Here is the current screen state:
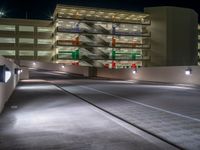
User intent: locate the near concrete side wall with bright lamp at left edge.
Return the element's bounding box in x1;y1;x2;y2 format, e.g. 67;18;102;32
0;56;19;113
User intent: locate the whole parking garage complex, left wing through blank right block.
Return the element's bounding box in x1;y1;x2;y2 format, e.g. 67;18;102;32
0;5;198;68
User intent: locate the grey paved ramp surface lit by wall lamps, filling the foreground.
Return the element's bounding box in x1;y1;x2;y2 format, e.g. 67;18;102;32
0;71;200;150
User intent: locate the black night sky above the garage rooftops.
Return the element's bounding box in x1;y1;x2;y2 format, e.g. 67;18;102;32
0;0;200;19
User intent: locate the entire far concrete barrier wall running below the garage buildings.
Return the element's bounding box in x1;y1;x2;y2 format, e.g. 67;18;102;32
20;61;200;85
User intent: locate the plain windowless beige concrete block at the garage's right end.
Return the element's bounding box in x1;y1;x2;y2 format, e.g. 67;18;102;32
145;7;198;66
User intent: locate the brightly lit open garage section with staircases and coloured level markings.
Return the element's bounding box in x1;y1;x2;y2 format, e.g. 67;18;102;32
54;5;151;68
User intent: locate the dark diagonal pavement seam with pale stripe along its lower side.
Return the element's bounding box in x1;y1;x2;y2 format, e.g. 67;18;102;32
52;83;182;150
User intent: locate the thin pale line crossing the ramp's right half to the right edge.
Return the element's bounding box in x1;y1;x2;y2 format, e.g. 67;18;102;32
79;86;200;122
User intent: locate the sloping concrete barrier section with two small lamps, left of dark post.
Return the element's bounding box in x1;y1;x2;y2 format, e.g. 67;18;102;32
20;60;89;77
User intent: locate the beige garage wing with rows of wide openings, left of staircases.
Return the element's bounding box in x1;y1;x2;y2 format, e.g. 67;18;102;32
0;18;53;62
